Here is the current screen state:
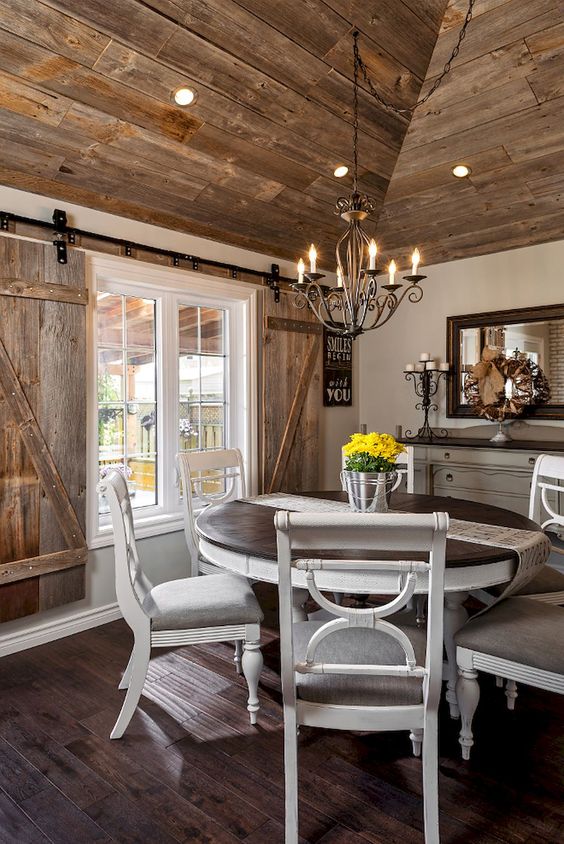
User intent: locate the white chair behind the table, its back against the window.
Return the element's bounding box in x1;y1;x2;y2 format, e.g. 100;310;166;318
176;448;247;576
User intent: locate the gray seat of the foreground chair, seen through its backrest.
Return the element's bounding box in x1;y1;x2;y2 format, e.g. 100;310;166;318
294;616;426;706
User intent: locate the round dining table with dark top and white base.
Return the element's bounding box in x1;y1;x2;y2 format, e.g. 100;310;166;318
196;492;540;718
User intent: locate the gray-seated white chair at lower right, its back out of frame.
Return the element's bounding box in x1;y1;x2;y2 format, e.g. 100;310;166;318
455;597;564;759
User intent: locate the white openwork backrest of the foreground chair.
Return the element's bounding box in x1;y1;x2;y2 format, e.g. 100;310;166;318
275;511;448;706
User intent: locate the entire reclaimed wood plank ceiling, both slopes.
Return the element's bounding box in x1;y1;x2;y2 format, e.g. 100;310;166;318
0;0;564;269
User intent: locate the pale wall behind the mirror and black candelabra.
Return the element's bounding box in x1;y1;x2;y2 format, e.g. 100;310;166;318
358;240;564;438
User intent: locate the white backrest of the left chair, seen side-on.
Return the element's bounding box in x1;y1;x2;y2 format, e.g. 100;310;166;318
97;469;153;626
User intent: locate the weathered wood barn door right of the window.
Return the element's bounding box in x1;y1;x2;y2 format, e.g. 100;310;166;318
262;291;323;492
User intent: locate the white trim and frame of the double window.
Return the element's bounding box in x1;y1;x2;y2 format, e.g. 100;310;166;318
86;254;259;548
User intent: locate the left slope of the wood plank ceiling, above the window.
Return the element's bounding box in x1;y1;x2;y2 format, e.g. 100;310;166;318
0;0;446;260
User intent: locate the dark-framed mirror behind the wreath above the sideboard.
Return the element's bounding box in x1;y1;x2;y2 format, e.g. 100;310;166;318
447;304;564;419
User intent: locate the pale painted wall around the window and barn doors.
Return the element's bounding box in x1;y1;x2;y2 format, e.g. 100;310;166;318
0;186;358;655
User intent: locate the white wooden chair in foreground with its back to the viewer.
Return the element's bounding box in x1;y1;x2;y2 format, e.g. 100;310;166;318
275;511;448;844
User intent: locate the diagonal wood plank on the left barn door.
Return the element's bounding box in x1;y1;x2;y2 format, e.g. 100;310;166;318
0;339;86;548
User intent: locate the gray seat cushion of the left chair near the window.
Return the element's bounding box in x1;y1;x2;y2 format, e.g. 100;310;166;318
143;574;263;630
